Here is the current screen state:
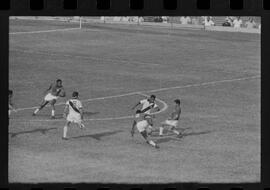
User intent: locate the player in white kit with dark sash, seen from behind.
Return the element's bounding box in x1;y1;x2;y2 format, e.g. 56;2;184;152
62;92;85;140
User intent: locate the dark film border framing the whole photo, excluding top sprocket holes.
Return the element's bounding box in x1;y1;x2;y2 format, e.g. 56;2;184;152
0;0;270;190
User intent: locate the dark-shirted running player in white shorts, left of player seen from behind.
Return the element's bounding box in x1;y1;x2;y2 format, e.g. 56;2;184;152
33;79;66;119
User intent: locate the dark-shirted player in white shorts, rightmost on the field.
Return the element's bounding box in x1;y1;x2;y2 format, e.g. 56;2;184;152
159;99;181;137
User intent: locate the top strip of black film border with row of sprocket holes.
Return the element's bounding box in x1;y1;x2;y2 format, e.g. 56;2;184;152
0;0;270;16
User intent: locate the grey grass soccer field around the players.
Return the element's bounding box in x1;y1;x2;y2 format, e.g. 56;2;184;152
9;20;261;183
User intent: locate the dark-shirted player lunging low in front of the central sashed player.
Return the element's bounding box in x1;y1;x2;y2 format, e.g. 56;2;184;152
136;115;159;148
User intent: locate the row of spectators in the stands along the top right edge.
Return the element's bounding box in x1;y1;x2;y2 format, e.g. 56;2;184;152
101;16;261;29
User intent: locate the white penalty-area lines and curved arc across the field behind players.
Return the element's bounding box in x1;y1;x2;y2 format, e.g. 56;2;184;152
10;75;260;121
